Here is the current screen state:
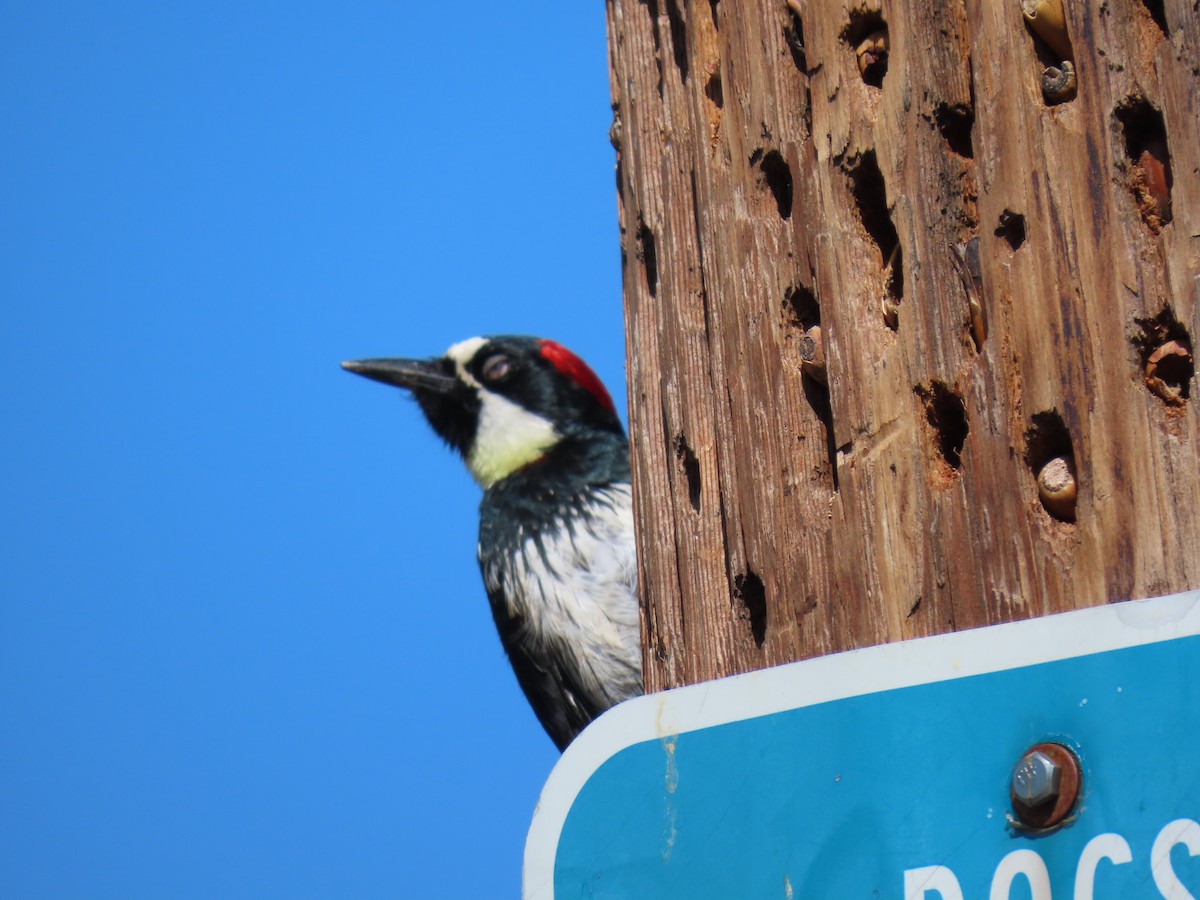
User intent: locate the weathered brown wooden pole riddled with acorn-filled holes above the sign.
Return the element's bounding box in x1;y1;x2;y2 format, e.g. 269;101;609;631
607;0;1200;690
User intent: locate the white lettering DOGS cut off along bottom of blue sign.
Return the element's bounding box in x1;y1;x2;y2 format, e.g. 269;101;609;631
904;818;1200;900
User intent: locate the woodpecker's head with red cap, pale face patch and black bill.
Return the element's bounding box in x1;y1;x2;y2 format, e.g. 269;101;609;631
342;335;624;488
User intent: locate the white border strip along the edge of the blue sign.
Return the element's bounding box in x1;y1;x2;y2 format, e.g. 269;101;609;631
522;590;1200;900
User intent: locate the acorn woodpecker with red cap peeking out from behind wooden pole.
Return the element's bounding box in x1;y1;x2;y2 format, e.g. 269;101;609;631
342;336;642;750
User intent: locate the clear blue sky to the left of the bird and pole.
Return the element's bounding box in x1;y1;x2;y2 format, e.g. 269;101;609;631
0;0;624;898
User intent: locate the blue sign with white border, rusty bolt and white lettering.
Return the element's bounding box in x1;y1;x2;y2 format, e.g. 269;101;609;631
524;590;1200;900
